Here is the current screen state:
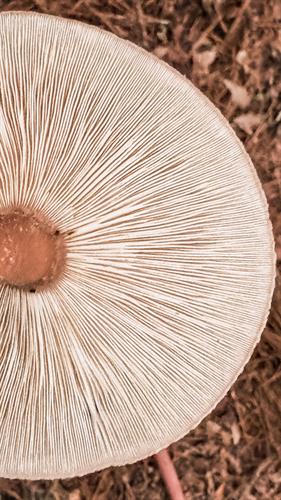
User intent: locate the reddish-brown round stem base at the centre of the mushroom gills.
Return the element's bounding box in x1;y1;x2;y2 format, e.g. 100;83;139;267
0;209;65;291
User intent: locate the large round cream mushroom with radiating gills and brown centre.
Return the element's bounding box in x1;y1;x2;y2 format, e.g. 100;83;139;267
0;12;275;479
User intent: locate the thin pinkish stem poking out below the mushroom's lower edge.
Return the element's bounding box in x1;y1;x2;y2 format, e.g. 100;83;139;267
154;450;184;500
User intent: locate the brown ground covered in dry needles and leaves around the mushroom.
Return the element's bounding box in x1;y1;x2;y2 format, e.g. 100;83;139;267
0;0;281;500
